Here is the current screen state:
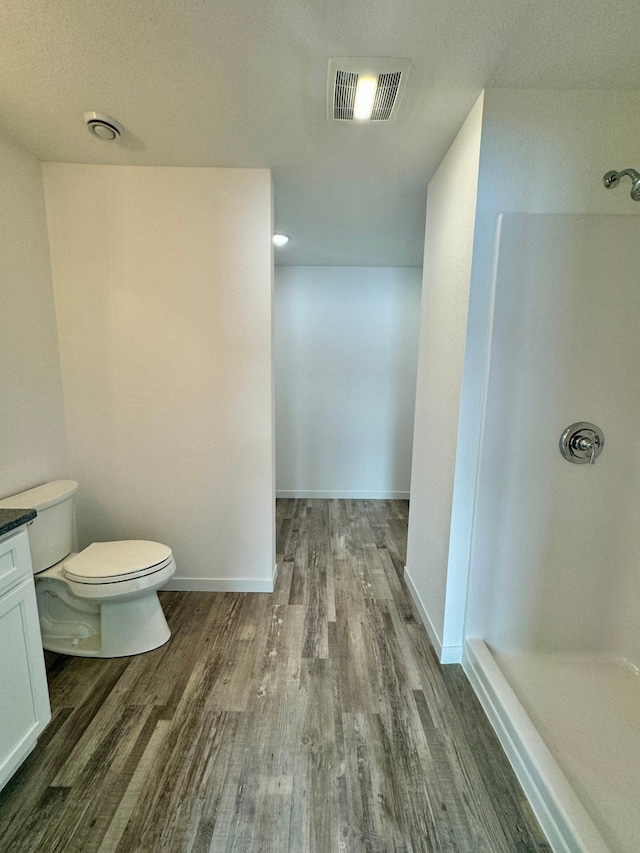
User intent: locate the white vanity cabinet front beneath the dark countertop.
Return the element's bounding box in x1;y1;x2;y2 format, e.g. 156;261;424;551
0;527;51;788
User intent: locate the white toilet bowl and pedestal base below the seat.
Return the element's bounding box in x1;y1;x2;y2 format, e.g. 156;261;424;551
36;578;171;658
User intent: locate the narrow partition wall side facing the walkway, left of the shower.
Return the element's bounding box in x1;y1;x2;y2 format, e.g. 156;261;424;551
405;97;483;661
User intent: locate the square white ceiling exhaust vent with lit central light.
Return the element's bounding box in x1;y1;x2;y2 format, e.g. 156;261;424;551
327;56;411;123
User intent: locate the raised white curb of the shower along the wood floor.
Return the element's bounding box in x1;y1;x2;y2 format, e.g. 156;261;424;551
462;638;611;853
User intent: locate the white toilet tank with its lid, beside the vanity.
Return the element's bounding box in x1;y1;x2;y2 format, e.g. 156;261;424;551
0;480;78;574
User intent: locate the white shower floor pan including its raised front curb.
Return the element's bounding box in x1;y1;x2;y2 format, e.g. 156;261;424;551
463;639;640;853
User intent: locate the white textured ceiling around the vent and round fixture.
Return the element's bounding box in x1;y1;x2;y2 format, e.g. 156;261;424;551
0;0;640;266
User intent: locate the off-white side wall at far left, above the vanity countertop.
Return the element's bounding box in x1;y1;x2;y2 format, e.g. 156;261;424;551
0;130;68;497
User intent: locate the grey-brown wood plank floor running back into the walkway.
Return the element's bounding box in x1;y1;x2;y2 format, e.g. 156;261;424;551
0;500;550;853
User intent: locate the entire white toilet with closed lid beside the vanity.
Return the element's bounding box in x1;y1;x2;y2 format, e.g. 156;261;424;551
0;480;176;658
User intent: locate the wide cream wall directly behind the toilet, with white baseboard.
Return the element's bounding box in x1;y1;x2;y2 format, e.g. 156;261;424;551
43;163;274;590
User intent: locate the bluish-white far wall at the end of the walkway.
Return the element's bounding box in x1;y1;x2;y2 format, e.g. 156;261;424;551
275;267;421;498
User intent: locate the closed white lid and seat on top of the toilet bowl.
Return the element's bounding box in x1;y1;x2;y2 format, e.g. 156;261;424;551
63;539;173;583
